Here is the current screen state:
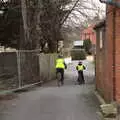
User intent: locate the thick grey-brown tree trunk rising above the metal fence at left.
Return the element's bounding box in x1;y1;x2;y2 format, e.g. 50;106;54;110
21;0;41;49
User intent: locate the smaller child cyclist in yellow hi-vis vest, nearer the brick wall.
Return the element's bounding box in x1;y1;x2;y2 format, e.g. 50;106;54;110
76;61;86;84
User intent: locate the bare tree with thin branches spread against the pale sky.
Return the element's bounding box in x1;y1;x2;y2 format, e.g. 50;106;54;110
62;0;105;50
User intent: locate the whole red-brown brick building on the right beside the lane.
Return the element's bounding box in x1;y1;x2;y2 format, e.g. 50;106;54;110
95;0;120;103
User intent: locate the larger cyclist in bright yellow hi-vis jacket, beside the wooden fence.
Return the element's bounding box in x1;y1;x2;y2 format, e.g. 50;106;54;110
56;55;67;85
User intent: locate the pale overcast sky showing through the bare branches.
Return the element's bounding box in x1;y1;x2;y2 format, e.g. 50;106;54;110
65;0;106;26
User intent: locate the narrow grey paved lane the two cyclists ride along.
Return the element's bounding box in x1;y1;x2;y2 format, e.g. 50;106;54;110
0;61;99;120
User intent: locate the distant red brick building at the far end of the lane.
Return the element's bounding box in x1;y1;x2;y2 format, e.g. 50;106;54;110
81;25;96;45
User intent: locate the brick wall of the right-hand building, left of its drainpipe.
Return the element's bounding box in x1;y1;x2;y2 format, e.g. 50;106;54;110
96;7;113;102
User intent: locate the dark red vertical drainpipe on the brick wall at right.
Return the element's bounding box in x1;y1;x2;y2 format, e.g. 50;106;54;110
113;8;116;101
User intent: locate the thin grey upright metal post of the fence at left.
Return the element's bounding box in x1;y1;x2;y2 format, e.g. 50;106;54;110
17;51;22;88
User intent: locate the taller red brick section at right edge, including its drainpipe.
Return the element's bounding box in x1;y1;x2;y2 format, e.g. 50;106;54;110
104;0;120;102
